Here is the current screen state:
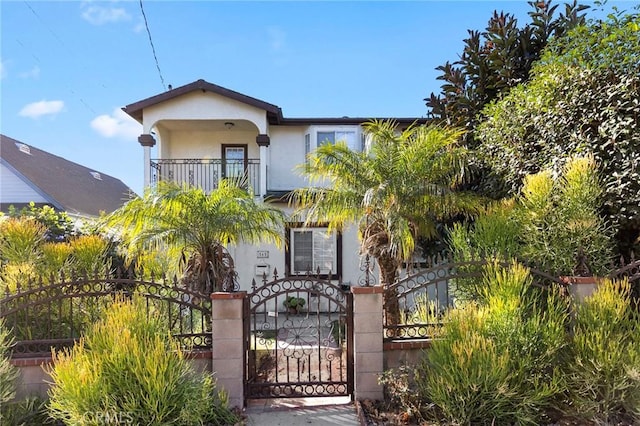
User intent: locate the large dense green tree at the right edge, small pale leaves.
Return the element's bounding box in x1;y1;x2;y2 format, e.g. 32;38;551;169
476;12;640;254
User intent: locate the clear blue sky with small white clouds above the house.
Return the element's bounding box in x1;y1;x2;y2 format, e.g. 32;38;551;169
0;0;634;194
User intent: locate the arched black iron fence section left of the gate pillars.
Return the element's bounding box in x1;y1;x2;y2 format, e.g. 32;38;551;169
0;272;211;358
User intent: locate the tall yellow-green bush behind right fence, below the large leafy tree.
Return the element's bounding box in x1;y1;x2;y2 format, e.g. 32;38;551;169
449;156;613;300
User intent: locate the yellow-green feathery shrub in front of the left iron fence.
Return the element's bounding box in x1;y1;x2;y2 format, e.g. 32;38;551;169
49;300;237;425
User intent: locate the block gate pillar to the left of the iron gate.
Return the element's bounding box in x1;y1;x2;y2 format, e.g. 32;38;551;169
211;291;247;408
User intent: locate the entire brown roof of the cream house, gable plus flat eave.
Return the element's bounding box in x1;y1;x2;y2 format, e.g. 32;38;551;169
122;79;428;126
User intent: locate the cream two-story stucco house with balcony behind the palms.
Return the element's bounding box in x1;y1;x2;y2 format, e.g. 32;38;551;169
123;80;424;290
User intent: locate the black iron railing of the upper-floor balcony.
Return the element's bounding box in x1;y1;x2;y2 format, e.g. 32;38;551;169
151;158;260;193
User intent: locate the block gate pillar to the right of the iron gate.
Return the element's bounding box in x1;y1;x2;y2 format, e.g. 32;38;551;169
351;286;384;401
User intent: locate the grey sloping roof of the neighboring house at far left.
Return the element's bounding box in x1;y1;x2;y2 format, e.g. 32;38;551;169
0;135;134;216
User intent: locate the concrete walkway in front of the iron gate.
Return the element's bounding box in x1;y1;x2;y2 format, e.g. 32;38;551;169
245;397;360;426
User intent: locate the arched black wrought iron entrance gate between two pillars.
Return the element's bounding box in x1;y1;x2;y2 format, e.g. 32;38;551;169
244;272;353;399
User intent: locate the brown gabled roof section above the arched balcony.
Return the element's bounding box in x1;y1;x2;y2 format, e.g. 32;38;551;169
122;79;282;124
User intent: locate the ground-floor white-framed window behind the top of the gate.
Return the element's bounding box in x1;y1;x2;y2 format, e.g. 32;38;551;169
286;227;340;275
